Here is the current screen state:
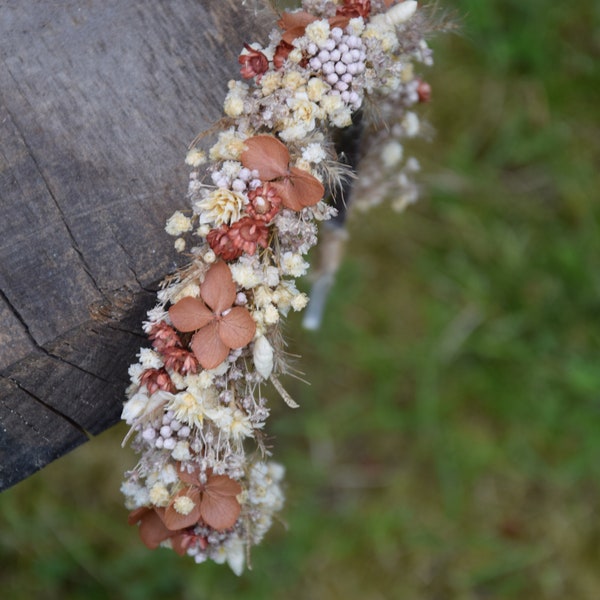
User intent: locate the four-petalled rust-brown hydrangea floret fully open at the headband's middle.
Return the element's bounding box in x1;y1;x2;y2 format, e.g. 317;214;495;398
169;261;256;369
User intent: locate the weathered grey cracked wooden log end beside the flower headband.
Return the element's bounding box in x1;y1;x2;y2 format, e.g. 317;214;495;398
0;0;270;489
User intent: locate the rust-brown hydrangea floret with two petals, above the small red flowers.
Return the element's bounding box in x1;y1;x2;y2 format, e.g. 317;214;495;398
241;135;325;210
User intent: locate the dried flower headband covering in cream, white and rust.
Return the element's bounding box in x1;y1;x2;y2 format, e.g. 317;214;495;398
122;0;429;574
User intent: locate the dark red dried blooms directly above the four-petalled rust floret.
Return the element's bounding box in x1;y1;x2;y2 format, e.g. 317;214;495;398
206;217;269;261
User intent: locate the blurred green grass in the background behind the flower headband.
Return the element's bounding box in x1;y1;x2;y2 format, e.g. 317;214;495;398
0;0;600;600
